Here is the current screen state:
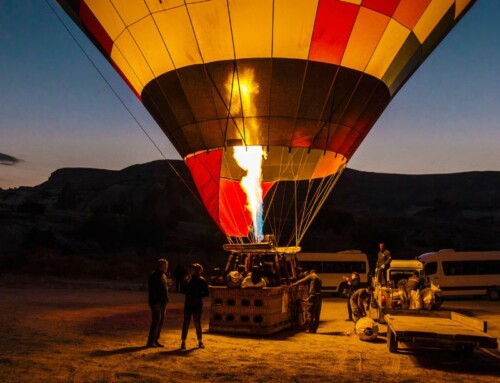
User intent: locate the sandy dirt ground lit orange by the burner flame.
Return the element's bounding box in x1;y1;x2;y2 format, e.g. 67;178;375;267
0;275;500;383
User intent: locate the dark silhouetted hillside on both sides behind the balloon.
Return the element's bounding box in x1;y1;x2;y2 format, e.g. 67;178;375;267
0;161;500;278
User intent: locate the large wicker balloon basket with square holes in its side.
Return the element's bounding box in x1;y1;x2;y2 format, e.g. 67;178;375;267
209;286;299;335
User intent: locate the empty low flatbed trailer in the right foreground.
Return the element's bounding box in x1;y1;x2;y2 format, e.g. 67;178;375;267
384;311;498;352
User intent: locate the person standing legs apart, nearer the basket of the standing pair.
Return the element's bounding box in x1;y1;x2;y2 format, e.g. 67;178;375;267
181;263;208;350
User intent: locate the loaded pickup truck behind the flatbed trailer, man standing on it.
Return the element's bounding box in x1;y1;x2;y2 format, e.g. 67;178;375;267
368;260;442;323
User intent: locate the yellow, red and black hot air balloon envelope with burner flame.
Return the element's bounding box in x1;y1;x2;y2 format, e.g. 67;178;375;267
58;0;475;245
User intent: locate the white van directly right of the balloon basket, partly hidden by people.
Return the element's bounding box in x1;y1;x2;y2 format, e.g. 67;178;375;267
297;250;369;296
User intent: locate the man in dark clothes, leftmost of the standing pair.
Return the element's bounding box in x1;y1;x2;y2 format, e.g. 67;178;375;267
146;258;168;347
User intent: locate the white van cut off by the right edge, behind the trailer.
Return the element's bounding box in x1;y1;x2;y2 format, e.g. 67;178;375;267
418;249;500;301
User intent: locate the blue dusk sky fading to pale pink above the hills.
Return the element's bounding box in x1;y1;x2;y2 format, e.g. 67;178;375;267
0;0;500;189
